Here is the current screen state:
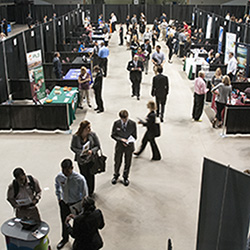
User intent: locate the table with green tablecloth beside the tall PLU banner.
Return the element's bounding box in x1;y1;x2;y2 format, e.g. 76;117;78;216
45;87;78;126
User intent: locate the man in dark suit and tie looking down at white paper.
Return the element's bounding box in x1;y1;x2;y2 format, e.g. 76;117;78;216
111;110;137;186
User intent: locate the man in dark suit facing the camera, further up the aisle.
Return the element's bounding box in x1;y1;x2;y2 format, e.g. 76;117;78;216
127;55;143;100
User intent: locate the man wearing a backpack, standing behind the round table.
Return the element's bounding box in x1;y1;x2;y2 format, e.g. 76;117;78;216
7;167;42;221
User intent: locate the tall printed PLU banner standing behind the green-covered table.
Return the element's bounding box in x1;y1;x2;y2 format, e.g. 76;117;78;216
27;50;46;100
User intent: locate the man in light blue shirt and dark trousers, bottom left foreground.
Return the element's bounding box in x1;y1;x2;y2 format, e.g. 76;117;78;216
55;159;88;249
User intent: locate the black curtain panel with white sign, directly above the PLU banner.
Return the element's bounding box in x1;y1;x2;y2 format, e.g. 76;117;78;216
24;26;42;53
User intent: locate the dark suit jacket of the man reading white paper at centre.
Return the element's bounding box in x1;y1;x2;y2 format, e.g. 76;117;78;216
111;119;137;147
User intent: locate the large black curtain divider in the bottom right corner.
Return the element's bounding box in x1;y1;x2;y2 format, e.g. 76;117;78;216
196;159;250;250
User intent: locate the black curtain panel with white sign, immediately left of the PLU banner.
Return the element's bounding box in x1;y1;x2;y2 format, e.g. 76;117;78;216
5;33;28;79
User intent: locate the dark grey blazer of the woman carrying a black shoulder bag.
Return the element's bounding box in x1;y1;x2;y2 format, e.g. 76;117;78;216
70;132;101;165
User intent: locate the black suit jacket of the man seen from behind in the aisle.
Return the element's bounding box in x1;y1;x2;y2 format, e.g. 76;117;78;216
151;74;169;101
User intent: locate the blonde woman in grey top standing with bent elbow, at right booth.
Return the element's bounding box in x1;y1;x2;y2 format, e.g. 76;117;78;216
211;76;232;128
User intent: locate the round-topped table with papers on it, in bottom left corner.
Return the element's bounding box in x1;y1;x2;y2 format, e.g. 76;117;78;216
1;218;49;250
